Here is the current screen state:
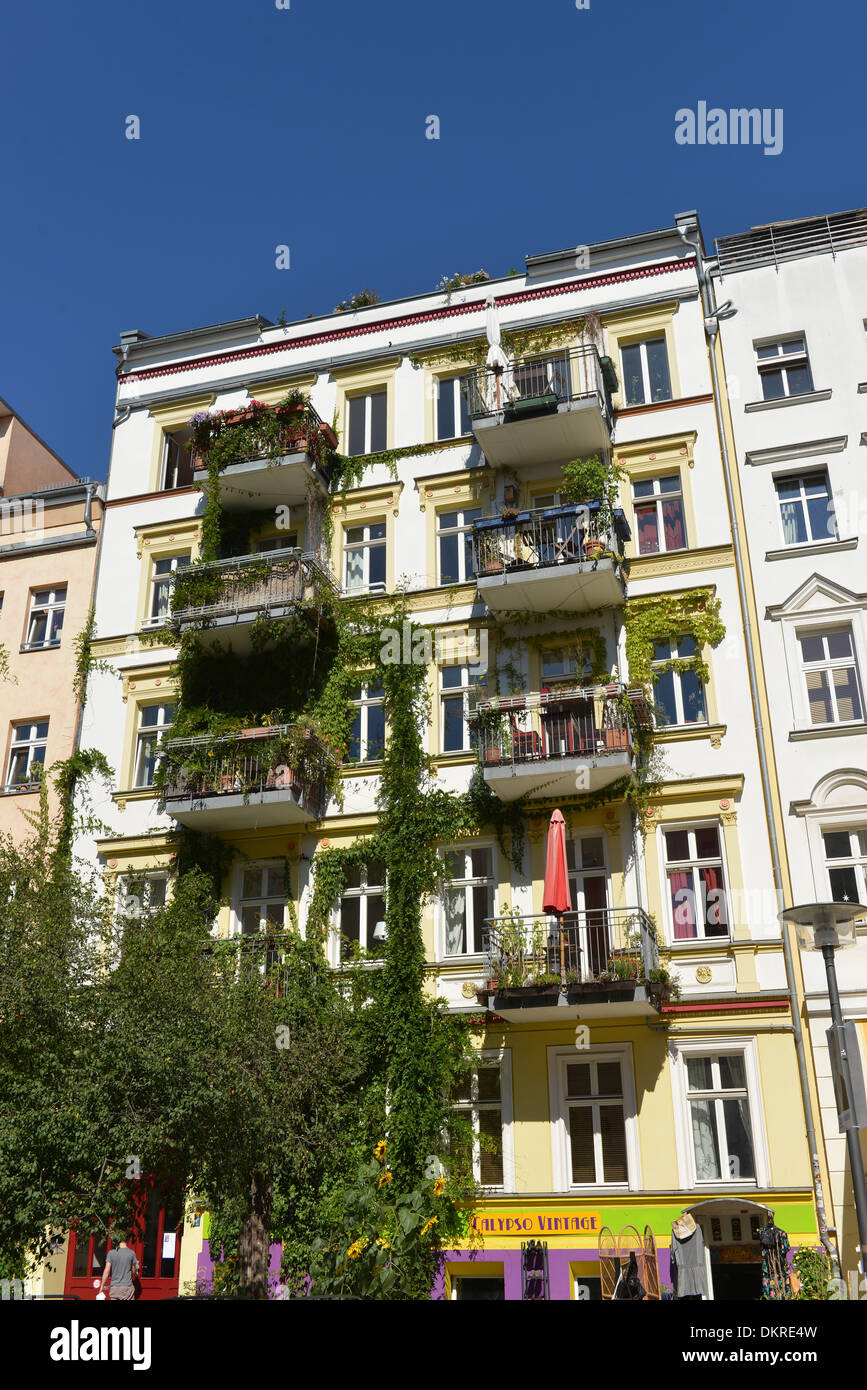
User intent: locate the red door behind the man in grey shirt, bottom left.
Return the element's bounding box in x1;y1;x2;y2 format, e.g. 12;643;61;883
64;1180;181;1298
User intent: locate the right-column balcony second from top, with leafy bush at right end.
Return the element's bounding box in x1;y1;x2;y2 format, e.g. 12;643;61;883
472;502;631;613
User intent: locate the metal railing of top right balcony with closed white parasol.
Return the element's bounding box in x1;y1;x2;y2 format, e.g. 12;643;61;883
467;343;611;423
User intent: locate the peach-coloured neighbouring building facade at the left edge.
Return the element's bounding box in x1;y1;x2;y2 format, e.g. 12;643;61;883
0;400;104;837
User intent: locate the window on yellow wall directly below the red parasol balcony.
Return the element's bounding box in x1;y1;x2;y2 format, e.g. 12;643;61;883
561;1058;629;1187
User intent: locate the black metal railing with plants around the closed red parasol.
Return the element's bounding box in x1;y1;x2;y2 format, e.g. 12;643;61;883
482;908;659;992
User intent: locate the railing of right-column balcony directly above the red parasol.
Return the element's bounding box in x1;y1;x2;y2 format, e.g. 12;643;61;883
470;682;650;767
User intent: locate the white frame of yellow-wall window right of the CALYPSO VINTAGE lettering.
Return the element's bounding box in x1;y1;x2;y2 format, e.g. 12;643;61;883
668;1037;771;1191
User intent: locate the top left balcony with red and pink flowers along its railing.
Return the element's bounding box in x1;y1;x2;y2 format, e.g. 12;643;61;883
193;406;336;512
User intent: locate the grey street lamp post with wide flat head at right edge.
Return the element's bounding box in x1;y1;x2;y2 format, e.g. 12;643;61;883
779;902;867;1273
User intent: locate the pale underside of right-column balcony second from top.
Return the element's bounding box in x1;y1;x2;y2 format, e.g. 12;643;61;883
477;557;627;613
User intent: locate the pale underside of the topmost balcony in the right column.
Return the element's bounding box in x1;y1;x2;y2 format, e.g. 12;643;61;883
472;396;611;468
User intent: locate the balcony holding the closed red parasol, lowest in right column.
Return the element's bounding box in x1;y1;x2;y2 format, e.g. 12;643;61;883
479;908;668;1023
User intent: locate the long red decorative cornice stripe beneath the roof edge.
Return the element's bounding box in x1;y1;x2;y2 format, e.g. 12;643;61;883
118;257;695;382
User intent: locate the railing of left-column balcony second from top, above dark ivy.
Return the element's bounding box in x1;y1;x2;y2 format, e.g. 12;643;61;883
170;548;338;627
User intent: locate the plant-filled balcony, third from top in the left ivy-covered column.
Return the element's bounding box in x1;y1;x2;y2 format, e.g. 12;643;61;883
163;724;333;833
